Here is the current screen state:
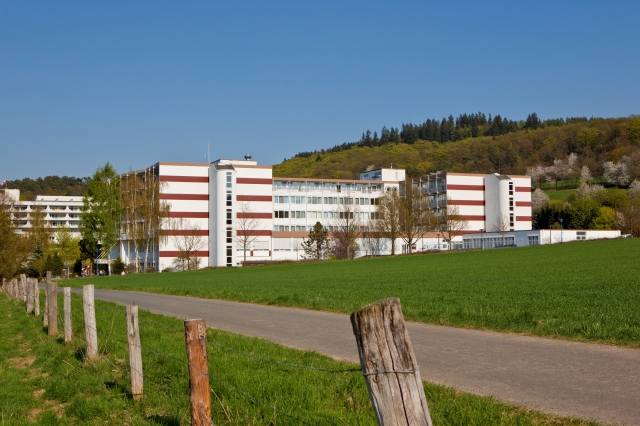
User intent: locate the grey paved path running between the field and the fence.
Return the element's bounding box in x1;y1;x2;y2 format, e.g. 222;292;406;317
65;289;640;425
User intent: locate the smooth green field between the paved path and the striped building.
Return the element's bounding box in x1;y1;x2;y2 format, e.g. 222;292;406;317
65;239;640;347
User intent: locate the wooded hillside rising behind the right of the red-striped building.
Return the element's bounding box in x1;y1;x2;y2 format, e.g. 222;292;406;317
273;114;640;179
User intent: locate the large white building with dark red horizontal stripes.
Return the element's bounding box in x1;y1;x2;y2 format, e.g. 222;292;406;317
111;155;531;270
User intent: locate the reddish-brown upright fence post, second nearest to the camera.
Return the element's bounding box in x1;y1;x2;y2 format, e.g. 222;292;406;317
184;319;213;426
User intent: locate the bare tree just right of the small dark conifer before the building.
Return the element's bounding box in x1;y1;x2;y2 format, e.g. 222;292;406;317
331;193;362;259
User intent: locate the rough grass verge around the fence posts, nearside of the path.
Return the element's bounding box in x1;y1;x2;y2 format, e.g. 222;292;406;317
0;294;596;425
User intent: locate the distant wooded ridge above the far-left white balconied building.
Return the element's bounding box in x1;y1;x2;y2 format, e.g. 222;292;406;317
7;176;89;201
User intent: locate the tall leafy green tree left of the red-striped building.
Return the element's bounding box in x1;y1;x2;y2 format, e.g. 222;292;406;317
80;162;122;276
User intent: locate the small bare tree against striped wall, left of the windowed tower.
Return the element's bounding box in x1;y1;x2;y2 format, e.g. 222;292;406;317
169;218;207;271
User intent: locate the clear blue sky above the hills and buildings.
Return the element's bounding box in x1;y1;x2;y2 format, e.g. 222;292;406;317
0;0;640;180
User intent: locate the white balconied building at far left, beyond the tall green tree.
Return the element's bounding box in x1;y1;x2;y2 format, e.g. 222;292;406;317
2;189;82;239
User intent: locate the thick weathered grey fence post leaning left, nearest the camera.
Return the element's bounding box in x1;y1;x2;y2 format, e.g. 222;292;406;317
351;298;433;426
